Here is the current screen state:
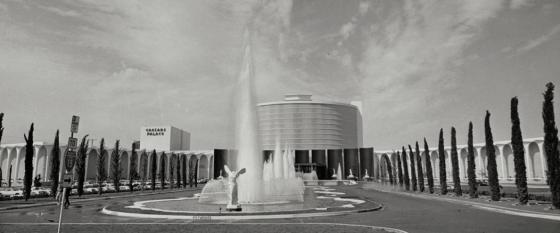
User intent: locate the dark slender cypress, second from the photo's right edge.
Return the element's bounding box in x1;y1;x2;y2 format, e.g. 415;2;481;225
511;97;529;205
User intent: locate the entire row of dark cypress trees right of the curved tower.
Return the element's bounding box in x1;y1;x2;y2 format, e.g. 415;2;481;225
390;83;560;208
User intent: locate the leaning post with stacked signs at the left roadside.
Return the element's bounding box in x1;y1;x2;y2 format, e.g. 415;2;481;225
58;116;80;233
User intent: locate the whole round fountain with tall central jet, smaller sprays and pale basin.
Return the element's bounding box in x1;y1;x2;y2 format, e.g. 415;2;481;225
102;33;378;219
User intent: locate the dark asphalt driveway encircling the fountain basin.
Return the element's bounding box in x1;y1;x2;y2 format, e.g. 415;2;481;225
0;186;560;233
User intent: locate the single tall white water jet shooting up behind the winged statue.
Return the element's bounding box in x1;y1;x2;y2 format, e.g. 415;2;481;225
235;31;263;203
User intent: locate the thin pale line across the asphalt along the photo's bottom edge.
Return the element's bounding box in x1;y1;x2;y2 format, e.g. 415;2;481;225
0;222;408;233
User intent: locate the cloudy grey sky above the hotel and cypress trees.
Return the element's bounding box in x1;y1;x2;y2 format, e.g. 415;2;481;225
0;0;560;150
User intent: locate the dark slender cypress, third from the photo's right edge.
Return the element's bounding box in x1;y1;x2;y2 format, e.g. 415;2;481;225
484;111;500;201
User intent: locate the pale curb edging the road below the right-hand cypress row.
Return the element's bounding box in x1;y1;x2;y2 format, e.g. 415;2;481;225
366;188;560;221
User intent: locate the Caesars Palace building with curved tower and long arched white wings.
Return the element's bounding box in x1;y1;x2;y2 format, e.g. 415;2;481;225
0;95;546;185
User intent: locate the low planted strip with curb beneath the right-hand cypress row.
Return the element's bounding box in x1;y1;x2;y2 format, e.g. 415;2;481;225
362;183;560;221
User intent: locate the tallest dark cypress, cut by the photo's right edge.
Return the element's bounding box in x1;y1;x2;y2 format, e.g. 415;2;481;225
542;83;560;209
